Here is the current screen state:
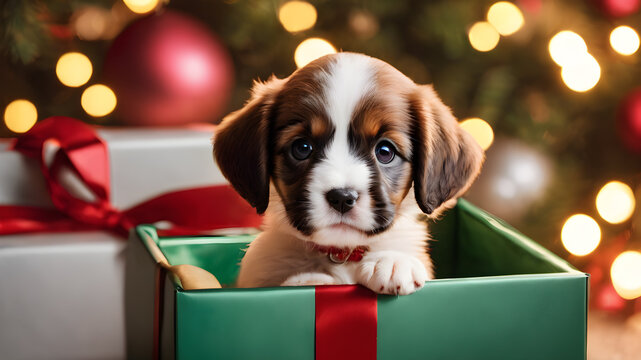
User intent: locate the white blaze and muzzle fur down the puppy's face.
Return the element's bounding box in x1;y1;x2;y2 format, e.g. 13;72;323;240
307;53;376;230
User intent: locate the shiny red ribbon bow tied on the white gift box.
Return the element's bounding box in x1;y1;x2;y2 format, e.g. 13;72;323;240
0;117;261;235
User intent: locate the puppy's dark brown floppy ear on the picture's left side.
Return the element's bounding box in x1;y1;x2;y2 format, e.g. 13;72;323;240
214;76;285;214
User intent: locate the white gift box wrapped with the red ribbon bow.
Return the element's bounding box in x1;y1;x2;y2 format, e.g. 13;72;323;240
0;127;226;359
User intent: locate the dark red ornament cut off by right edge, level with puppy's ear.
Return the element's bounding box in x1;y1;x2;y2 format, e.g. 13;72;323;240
618;88;641;154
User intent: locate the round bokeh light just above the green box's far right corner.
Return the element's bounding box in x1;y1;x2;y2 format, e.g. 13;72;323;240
561;214;601;256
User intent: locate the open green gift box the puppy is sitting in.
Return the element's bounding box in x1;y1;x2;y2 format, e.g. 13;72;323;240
125;200;588;359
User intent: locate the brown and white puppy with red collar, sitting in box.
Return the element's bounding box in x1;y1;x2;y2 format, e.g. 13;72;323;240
214;52;483;294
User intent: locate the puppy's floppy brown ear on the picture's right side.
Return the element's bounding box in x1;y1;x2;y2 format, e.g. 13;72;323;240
410;85;484;215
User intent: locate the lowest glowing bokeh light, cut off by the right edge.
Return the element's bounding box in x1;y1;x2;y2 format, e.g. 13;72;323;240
610;251;641;300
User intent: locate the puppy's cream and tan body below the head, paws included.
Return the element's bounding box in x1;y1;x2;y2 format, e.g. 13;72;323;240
237;191;433;295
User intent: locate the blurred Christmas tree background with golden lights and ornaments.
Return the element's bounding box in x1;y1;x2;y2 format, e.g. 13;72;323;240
0;0;641;359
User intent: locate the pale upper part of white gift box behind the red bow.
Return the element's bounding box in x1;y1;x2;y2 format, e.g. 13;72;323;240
0;126;226;208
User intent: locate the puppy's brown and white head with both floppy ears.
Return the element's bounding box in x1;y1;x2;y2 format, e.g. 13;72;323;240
214;53;483;245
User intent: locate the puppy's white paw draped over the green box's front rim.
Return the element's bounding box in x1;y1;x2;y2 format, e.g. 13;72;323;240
358;251;431;295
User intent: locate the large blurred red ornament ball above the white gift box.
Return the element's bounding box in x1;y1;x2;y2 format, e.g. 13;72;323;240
104;11;234;126
